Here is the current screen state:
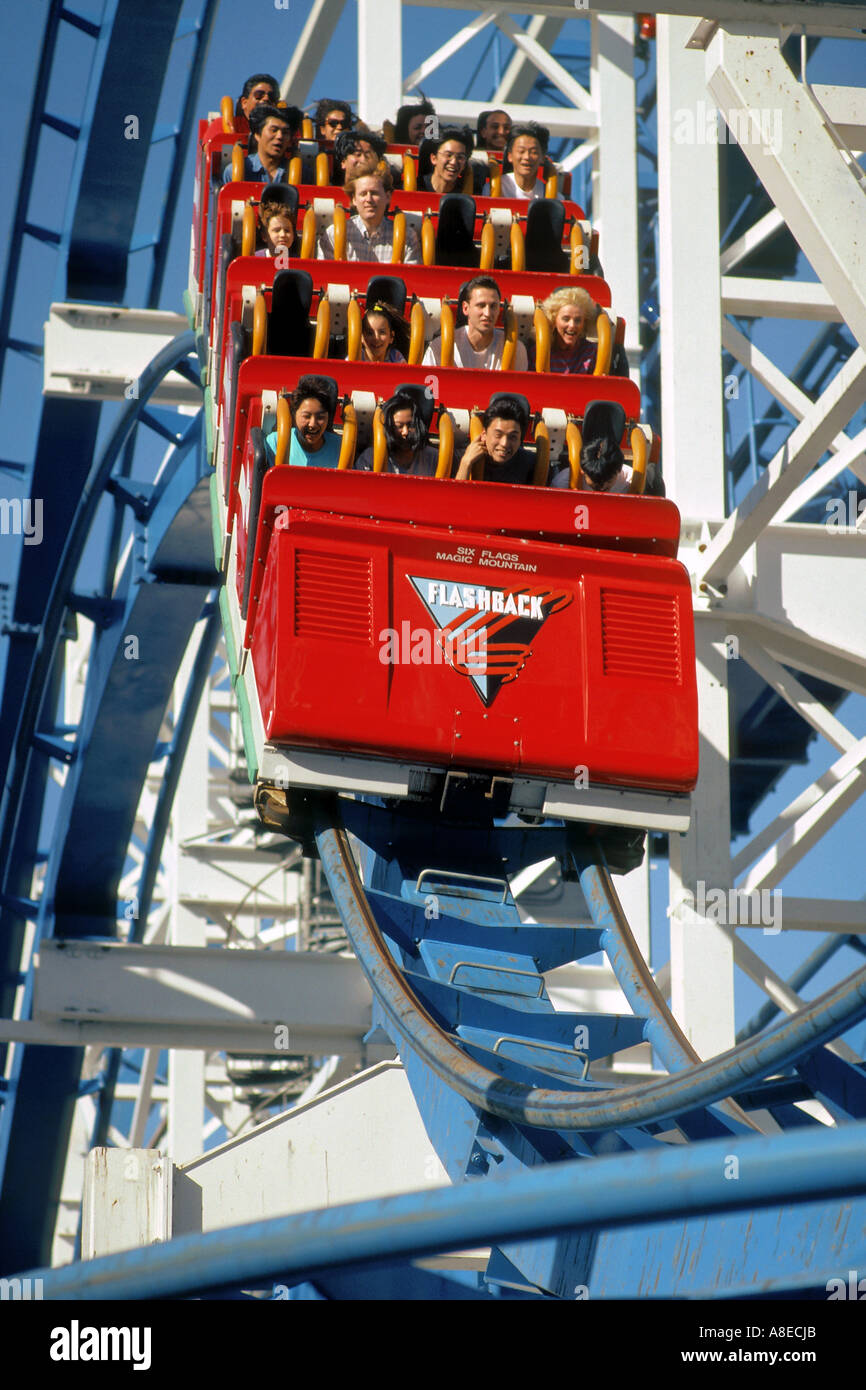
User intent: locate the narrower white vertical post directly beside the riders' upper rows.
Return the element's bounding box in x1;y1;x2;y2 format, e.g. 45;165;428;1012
591;14;641;364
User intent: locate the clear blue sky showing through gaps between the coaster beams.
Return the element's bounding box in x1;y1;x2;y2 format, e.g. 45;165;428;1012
0;0;866;1045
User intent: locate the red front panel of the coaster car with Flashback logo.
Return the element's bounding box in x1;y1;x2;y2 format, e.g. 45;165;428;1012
252;484;698;792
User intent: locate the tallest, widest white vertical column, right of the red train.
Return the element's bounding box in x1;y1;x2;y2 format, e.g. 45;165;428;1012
657;15;735;1058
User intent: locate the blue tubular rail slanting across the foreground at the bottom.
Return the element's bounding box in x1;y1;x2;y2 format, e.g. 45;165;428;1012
15;1125;866;1301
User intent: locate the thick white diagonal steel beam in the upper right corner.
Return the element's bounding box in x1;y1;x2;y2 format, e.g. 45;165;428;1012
706;25;866;348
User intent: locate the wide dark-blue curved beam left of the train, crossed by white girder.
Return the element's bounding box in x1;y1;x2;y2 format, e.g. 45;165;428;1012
0;472;215;1268
